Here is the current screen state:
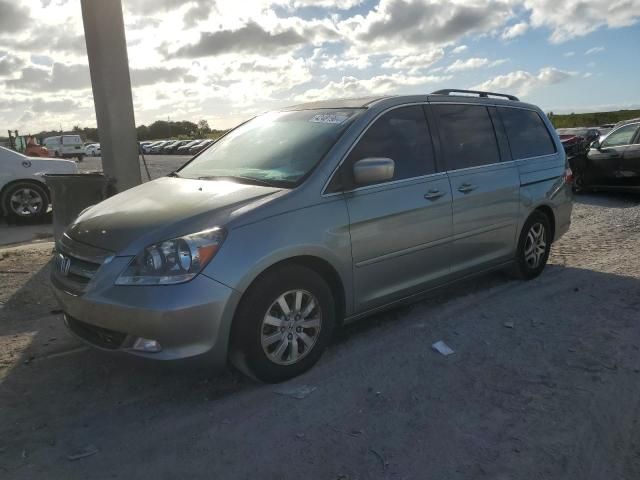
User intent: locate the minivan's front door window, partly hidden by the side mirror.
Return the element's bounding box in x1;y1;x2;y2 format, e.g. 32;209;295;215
345;105;436;185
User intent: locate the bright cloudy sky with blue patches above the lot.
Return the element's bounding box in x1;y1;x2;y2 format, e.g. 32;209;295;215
0;0;640;131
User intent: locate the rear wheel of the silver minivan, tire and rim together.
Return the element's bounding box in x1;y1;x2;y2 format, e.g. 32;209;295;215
512;211;553;280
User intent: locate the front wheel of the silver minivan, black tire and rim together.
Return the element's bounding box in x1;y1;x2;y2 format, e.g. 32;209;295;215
233;265;336;383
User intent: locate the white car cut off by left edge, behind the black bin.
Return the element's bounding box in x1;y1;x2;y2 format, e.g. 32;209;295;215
0;142;78;218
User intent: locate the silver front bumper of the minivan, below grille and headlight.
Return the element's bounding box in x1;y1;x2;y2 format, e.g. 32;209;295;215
51;257;240;367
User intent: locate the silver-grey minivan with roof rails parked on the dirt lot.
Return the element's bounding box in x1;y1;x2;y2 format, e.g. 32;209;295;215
52;90;572;382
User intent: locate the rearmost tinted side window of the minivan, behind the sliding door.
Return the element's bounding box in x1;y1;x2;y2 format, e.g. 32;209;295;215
498;107;556;160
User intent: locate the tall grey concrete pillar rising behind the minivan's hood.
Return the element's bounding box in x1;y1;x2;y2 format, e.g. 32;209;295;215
80;0;142;192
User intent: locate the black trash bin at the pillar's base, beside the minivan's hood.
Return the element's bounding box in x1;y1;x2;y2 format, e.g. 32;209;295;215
44;173;112;243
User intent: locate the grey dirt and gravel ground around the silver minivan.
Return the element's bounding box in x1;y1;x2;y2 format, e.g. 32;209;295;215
0;194;640;480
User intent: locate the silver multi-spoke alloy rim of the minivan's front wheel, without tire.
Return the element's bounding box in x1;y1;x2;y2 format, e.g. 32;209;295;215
260;290;322;365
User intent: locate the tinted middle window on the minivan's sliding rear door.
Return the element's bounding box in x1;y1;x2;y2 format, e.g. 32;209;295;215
432;105;500;170
